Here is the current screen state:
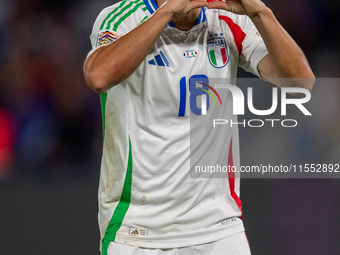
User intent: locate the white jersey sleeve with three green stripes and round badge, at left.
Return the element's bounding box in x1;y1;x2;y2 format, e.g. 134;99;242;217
88;0;148;56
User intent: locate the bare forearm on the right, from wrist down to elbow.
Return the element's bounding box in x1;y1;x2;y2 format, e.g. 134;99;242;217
251;7;314;90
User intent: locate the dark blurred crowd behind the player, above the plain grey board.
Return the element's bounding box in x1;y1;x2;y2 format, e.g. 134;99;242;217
0;0;340;181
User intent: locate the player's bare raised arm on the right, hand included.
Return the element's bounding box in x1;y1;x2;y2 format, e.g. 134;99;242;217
208;0;315;90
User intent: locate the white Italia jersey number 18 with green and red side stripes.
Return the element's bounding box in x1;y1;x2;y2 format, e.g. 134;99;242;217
90;0;268;254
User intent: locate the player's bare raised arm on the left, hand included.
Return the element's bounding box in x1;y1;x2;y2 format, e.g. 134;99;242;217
84;0;207;94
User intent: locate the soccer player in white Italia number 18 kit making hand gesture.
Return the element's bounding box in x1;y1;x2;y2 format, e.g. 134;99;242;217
84;0;314;255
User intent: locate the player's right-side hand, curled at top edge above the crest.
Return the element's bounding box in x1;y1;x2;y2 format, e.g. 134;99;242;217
207;0;266;18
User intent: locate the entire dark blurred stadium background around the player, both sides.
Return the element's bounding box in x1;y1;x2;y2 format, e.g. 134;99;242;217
0;0;340;255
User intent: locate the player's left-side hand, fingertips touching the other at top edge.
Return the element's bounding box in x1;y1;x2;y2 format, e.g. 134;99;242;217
161;0;208;17
